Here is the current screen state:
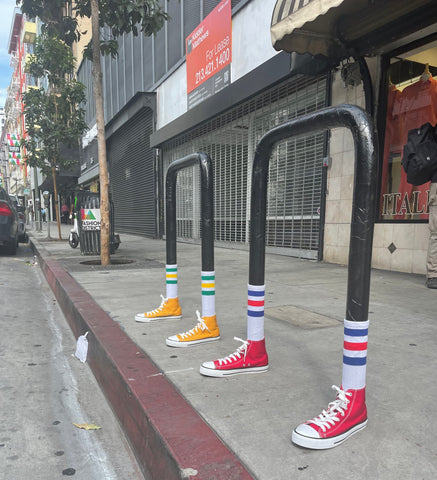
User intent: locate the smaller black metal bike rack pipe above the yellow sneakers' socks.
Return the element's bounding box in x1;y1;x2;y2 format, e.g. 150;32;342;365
165;152;214;271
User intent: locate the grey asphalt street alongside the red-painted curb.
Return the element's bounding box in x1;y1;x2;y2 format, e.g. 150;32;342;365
0;244;144;480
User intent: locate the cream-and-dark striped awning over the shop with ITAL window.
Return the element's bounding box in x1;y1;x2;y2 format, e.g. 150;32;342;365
270;0;437;59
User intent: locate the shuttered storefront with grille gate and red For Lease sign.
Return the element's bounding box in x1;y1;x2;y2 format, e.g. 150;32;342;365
151;0;331;259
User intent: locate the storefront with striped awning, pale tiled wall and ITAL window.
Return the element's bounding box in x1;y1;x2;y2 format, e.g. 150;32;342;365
271;0;437;273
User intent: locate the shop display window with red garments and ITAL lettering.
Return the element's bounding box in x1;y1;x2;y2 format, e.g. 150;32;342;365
380;41;437;221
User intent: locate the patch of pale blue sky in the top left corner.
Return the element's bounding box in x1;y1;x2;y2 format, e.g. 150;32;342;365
0;0;16;107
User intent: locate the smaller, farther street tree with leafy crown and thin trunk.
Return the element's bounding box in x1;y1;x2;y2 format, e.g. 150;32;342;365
23;32;88;240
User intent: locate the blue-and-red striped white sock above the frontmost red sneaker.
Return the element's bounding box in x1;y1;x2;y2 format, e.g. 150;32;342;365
342;320;369;390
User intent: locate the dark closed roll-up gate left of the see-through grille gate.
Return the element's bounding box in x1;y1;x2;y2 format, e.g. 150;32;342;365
107;108;157;238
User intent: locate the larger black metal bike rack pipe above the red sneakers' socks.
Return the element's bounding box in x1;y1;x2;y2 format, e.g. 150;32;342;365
249;105;377;322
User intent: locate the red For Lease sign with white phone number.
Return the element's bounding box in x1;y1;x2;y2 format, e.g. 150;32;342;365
186;0;232;93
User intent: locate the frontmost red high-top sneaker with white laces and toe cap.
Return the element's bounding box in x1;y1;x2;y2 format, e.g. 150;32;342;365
291;385;367;449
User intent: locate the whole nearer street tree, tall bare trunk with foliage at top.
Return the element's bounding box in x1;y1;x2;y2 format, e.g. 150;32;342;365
17;0;168;265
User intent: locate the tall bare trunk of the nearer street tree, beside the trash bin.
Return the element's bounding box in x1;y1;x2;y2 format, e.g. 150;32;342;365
91;0;111;265
